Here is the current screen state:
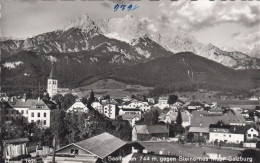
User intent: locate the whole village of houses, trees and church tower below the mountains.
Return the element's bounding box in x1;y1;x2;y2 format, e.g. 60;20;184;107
0;70;260;163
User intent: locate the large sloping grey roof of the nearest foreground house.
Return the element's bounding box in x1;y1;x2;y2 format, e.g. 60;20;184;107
75;132;127;158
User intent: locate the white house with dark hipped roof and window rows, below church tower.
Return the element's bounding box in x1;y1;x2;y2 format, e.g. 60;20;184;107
28;99;57;128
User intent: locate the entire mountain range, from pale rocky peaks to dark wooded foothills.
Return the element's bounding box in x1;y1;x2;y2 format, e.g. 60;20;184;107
0;15;260;95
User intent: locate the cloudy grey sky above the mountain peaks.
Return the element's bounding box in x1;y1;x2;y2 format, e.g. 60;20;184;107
0;0;260;47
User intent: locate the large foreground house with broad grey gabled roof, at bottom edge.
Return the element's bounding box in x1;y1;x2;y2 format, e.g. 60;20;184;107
43;132;132;163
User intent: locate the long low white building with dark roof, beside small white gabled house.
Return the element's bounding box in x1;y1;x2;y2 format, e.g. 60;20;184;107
209;122;246;144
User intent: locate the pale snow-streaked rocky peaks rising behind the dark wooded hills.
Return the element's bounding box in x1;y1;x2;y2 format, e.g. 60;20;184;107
0;14;260;69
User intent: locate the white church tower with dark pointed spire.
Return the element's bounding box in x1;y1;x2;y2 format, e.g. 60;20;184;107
47;65;58;98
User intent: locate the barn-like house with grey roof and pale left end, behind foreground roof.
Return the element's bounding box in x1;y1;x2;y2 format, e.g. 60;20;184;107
132;125;169;141
